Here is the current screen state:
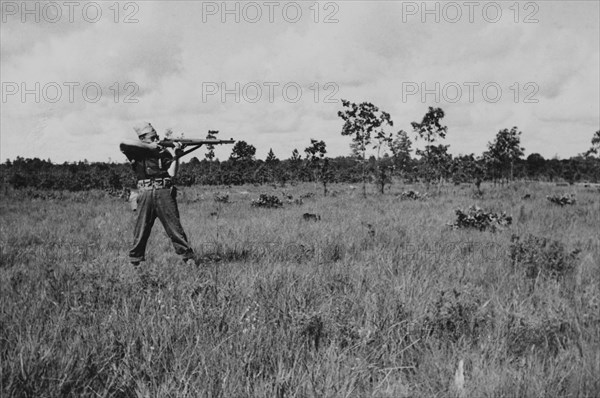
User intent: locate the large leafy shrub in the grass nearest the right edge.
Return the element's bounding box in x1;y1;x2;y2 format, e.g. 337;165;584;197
510;235;580;279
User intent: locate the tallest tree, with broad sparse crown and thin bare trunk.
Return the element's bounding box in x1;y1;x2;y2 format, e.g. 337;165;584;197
338;99;394;197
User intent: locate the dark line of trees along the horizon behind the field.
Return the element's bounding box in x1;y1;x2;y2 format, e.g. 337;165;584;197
0;104;600;194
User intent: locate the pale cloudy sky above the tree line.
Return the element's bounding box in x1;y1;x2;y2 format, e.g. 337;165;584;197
0;0;600;163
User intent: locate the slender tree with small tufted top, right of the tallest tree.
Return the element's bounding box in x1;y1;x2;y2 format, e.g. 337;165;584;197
411;106;452;183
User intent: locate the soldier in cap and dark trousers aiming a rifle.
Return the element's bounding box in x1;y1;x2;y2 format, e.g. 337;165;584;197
120;123;194;266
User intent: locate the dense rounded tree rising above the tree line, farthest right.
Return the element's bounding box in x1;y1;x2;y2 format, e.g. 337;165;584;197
484;126;524;181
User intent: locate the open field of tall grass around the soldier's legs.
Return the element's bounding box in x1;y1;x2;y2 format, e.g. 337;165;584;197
0;183;600;398
